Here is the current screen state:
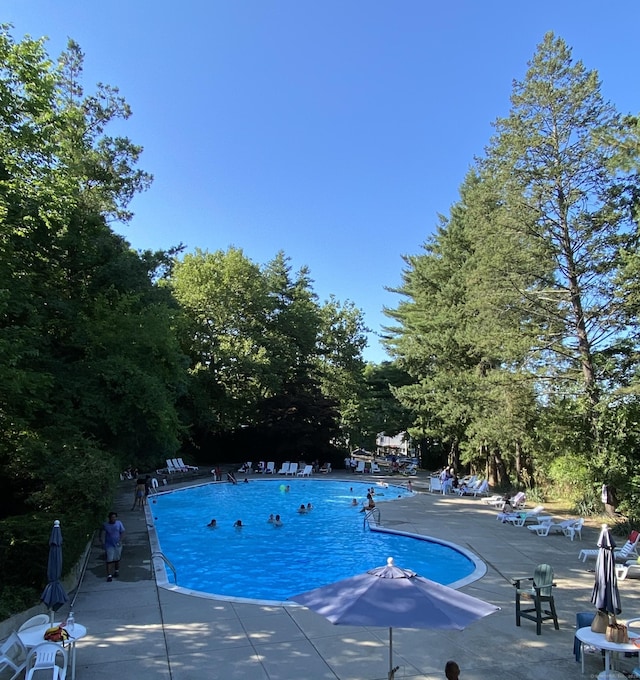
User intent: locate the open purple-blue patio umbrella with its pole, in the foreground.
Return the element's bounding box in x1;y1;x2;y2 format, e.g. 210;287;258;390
289;557;500;680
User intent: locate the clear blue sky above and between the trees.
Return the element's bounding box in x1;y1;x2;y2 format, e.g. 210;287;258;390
5;0;640;361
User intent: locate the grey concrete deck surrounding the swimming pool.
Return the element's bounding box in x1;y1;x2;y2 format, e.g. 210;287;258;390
60;472;640;680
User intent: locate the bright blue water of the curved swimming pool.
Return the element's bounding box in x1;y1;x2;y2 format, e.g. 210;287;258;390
149;477;476;601
